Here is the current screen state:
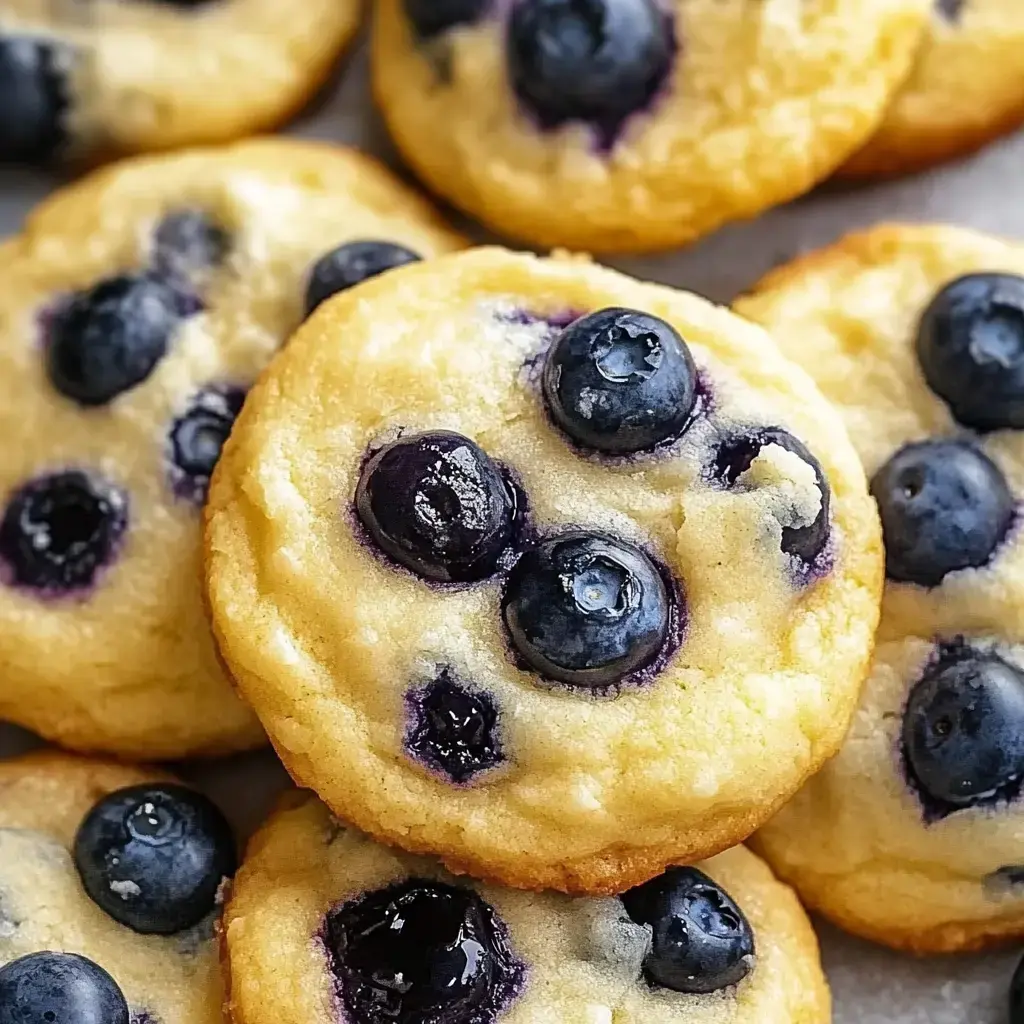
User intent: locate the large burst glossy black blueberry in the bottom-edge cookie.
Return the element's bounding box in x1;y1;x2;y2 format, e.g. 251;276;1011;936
326;879;523;1024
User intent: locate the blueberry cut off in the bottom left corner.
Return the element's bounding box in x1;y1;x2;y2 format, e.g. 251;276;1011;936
0;952;128;1024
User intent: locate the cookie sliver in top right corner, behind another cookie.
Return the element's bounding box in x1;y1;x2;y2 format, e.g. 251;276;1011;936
840;0;1024;177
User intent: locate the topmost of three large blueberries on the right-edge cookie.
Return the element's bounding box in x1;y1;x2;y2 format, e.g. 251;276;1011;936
918;273;1024;430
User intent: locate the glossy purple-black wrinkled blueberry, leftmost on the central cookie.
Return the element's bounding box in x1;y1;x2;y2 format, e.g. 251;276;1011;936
355;430;516;583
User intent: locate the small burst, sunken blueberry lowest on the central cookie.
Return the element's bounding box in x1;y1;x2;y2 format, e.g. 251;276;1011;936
406;668;504;784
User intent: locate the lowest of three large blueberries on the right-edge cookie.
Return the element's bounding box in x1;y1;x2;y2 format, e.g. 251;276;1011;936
902;643;1024;816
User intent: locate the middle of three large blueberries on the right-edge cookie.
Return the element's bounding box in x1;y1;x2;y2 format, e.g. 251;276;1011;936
871;440;1014;587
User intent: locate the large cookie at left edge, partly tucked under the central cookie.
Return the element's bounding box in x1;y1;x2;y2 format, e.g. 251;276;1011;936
0;140;460;760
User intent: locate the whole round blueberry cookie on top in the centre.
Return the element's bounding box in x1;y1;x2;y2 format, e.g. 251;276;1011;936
207;249;882;893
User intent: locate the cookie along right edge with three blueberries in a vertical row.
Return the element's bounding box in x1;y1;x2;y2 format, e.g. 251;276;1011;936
739;225;1024;950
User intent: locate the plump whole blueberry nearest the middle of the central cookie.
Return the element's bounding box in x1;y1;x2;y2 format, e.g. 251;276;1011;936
502;530;670;687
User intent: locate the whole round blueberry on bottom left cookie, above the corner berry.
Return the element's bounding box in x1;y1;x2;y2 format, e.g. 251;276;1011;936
75;782;236;935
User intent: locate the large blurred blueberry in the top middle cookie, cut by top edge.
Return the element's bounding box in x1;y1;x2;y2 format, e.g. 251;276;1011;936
507;0;675;144
